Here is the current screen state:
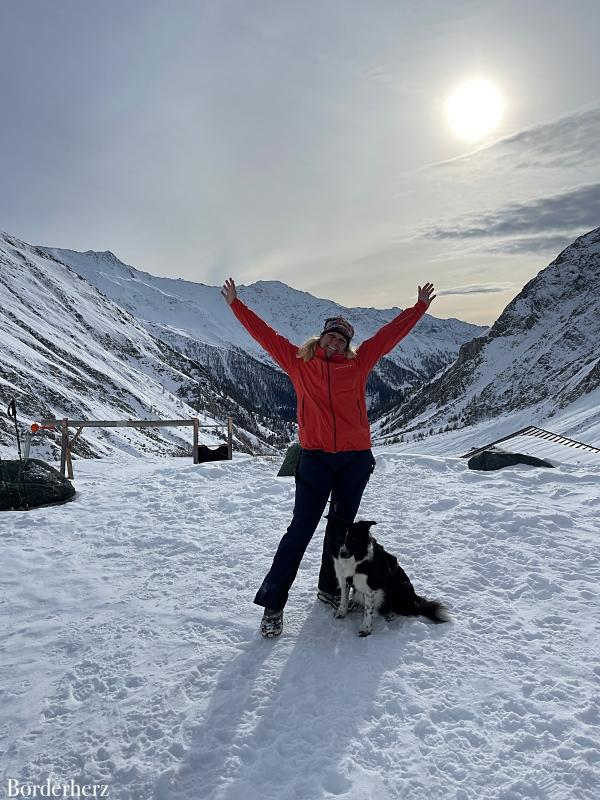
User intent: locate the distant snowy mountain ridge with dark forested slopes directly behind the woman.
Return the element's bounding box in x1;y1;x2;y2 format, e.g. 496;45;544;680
47;248;486;418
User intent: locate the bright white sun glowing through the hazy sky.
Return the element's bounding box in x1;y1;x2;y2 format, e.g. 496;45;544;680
446;78;504;142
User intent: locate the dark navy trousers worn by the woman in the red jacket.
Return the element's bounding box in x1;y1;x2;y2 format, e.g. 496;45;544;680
254;450;375;611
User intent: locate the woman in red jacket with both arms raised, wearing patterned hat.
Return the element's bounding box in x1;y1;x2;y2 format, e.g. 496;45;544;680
221;278;435;638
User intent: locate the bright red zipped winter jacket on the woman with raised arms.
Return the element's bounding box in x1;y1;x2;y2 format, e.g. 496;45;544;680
231;299;427;453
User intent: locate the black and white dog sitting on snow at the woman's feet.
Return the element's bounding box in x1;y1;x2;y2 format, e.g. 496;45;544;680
329;518;449;636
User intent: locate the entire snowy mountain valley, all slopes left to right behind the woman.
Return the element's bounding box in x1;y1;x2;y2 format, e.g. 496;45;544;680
0;229;600;456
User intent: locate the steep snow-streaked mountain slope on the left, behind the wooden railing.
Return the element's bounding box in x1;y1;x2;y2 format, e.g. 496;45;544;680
0;234;290;455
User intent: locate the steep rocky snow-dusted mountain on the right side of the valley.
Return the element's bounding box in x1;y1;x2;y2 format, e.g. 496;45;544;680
379;228;600;443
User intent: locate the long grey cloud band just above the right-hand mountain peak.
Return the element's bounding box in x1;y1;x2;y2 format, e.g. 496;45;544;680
423;183;600;242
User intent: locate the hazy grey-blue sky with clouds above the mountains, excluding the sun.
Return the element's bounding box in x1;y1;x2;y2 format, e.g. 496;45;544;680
0;0;600;324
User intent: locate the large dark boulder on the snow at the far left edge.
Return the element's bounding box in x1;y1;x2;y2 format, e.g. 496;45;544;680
0;458;75;511
